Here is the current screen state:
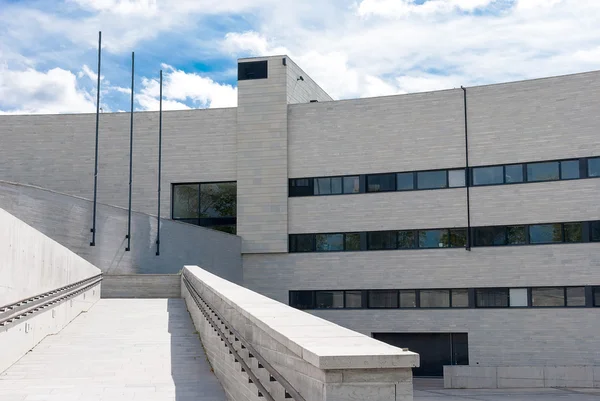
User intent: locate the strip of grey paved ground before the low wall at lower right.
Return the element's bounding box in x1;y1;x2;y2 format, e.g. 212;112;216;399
414;378;600;401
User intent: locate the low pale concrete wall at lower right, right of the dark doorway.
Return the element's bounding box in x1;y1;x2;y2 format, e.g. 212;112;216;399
444;366;600;388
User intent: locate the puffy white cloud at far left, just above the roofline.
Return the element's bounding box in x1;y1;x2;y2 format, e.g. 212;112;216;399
0;67;96;114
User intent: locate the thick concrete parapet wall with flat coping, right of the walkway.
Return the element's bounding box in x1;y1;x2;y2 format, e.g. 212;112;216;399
181;266;419;401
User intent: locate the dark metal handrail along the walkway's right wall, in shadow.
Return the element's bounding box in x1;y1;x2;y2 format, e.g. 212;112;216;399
182;273;306;401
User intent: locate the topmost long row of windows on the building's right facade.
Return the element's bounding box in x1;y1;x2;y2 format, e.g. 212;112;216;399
289;157;600;196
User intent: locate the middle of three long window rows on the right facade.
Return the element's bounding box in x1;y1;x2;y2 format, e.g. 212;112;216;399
289;221;600;252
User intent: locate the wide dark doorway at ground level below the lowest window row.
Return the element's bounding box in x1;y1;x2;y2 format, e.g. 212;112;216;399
373;333;469;376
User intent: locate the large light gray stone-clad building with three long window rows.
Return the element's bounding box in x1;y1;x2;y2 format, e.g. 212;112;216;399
0;56;600;387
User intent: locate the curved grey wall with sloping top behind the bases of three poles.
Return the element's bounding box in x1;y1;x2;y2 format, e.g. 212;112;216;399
0;181;242;283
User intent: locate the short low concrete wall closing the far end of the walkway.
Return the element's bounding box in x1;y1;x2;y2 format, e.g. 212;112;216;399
101;274;181;298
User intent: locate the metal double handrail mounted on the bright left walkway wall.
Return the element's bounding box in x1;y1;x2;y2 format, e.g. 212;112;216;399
0;274;102;327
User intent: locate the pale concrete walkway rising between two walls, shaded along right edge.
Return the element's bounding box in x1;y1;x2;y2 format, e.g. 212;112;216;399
0;299;226;401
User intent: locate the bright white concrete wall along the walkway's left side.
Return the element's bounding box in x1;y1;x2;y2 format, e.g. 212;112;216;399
0;209;100;372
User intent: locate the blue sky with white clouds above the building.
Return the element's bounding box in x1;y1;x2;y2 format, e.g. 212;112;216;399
0;0;600;114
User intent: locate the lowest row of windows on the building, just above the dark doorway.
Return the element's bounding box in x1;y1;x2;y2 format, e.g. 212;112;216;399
289;286;600;309
